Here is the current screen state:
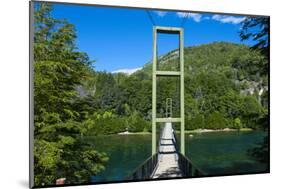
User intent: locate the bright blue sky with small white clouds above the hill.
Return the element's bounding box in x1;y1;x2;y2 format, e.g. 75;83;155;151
48;4;252;72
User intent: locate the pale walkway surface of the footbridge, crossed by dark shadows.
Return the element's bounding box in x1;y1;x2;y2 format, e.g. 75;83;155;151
152;122;182;178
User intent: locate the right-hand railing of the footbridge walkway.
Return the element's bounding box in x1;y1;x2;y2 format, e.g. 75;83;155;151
170;129;205;177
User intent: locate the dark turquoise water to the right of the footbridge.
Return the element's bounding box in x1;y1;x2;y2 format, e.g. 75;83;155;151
186;132;267;175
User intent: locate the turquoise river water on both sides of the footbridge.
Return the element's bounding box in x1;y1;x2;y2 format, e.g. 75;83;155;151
88;131;267;182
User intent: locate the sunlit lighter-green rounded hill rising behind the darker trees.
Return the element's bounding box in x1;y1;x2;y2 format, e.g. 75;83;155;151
135;42;268;100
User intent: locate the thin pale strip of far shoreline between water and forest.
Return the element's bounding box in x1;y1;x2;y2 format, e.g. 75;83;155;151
118;128;253;135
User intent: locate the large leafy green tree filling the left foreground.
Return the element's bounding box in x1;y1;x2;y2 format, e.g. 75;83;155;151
34;3;107;186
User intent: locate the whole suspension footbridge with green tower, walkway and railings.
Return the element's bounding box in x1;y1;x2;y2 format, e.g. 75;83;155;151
126;26;203;180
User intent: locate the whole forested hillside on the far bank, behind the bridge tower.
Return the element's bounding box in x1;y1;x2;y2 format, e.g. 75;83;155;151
71;42;268;135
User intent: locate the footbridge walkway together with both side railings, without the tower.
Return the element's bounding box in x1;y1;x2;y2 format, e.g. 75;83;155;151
126;118;204;180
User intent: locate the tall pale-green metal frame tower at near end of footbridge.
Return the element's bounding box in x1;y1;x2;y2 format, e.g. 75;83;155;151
152;26;185;155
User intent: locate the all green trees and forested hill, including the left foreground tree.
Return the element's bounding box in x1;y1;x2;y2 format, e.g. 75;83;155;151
34;3;269;186
